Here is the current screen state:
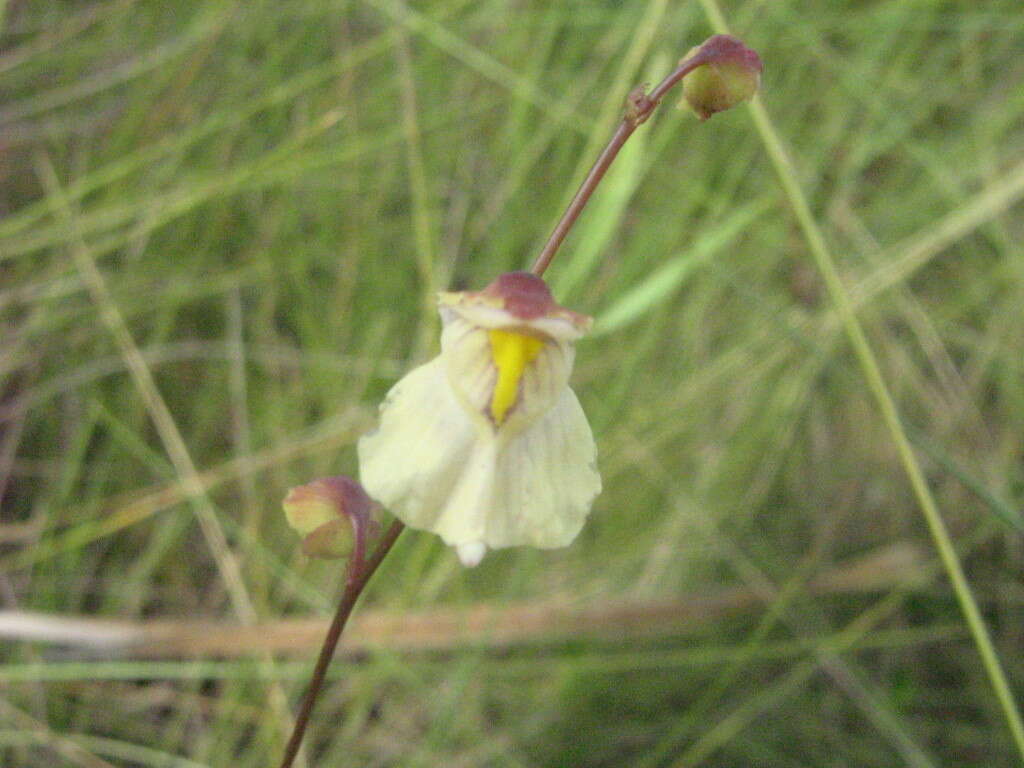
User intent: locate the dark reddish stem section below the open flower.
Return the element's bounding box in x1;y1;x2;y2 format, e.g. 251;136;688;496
281;520;406;768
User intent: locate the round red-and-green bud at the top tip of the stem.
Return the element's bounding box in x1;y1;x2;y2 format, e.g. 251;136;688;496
682;35;764;120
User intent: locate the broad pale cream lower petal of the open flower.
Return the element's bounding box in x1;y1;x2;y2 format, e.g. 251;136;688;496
358;357;601;564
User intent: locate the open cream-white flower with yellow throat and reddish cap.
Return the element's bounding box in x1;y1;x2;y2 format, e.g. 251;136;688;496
358;272;601;565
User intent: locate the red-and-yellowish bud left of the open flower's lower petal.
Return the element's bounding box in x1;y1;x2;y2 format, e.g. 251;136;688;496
284;475;373;558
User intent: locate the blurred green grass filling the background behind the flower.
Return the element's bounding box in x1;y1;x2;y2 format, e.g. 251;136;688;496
0;0;1024;766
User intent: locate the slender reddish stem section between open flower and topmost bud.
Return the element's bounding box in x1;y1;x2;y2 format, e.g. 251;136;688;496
532;50;712;275
